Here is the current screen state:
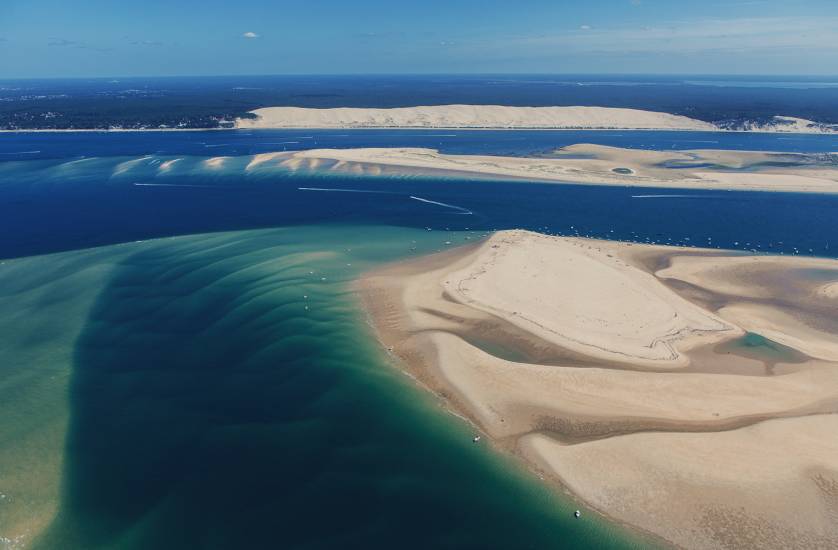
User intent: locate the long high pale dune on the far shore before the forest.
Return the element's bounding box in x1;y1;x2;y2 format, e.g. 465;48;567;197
236;105;718;131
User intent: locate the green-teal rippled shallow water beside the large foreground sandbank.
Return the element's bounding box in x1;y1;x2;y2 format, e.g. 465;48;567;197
0;226;647;549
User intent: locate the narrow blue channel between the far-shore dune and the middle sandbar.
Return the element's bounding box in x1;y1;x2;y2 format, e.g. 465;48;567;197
0;129;838;161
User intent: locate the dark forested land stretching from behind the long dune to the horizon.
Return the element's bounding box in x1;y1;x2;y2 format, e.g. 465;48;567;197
0;74;838;131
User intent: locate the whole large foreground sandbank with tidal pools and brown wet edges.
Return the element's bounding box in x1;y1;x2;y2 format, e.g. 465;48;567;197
358;231;838;549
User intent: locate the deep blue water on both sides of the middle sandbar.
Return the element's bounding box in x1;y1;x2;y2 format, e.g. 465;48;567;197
0;130;838;257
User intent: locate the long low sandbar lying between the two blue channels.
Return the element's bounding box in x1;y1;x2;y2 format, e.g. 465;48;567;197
268;144;838;198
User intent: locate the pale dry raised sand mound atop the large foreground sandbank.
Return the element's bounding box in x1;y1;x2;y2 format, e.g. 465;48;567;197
443;233;736;366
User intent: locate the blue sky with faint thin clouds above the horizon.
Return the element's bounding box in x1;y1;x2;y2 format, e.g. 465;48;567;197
0;0;838;78
